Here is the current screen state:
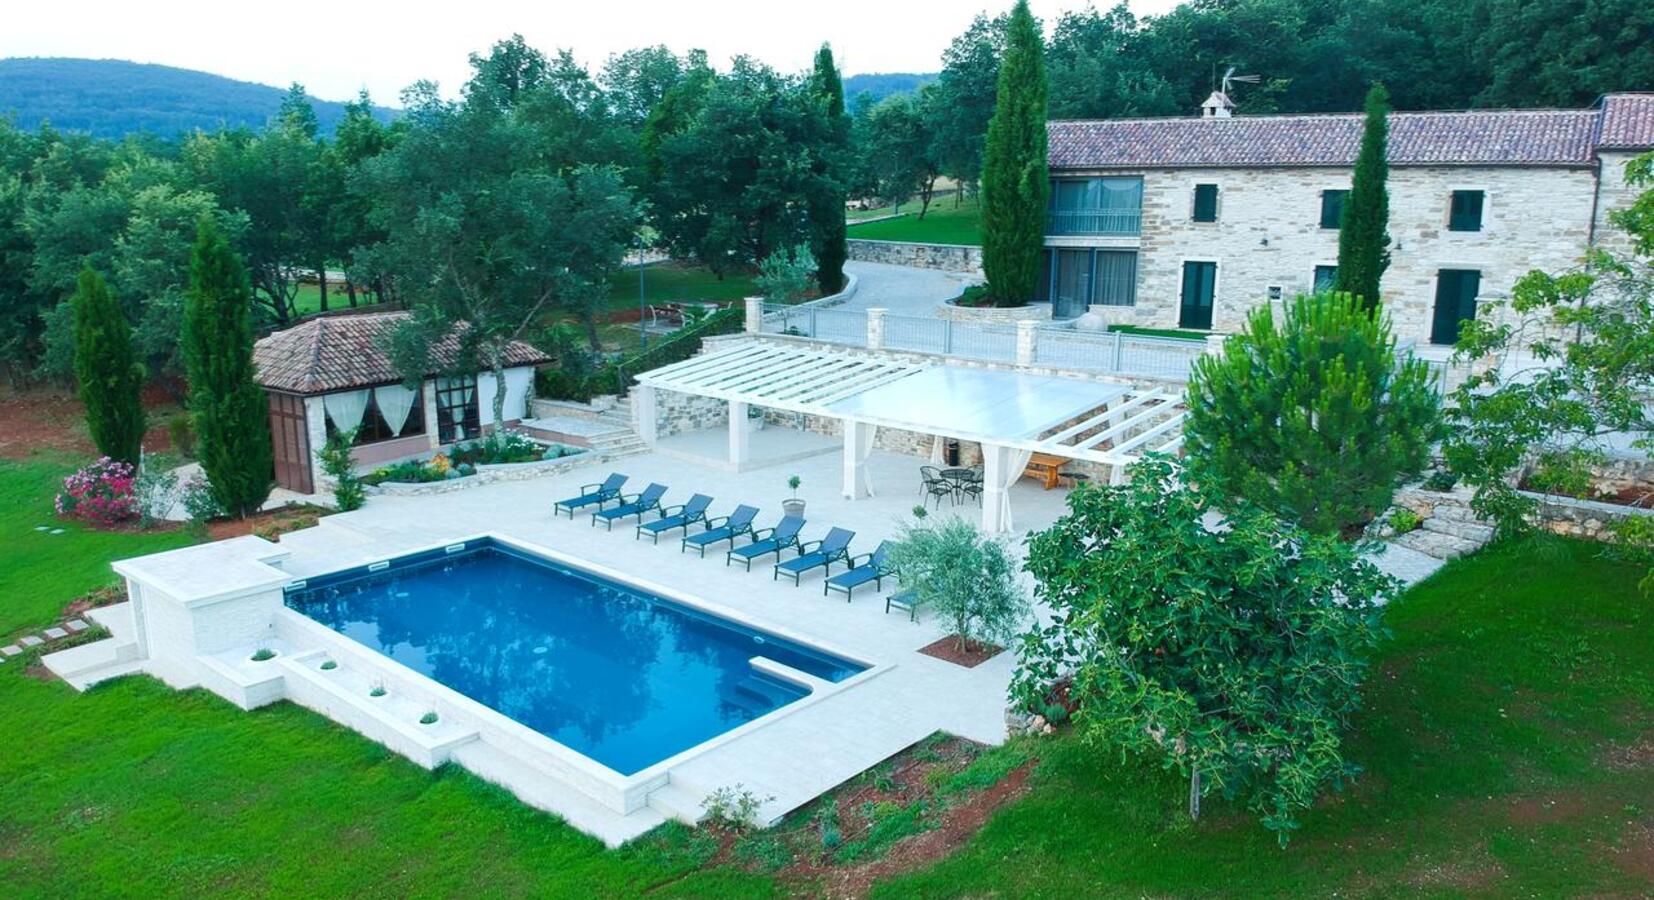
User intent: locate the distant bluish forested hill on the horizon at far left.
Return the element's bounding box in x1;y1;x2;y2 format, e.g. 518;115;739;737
0;58;392;137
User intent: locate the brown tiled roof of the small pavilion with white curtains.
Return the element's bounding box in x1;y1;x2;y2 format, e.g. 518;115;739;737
253;313;551;394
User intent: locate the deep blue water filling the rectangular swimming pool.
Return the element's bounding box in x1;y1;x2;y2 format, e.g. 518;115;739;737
288;539;865;774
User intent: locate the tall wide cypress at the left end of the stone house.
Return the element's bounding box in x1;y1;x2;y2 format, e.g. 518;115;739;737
982;0;1050;306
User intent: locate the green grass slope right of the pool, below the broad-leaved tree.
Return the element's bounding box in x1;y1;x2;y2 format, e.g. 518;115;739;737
875;539;1654;897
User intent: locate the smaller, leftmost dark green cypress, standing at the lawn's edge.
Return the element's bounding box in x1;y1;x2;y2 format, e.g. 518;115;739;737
69;266;144;465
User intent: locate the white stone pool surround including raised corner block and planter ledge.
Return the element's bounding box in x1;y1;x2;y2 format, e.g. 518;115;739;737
98;533;890;845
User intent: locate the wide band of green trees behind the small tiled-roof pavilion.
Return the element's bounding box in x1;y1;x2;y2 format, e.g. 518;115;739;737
0;36;850;389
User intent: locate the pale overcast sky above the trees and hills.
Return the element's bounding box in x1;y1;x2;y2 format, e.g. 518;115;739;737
0;0;1176;104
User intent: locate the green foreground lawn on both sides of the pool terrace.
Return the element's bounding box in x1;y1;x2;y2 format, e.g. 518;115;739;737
0;450;1654;897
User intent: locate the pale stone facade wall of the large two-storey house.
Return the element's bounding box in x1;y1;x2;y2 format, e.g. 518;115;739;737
1045;167;1601;344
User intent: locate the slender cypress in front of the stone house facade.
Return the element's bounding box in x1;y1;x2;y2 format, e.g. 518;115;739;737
1336;84;1389;309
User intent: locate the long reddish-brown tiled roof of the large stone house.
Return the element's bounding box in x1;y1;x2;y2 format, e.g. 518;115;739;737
1049;94;1654;169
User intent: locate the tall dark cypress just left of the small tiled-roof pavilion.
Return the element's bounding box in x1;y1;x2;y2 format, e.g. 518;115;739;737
184;217;275;516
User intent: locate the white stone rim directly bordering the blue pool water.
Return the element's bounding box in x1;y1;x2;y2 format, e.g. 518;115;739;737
276;531;896;816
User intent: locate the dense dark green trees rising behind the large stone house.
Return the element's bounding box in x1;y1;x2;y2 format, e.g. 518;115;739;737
852;0;1654;215
